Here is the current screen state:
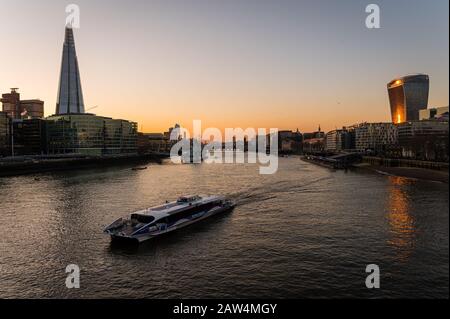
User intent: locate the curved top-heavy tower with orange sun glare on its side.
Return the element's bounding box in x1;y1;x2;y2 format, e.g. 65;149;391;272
387;74;430;124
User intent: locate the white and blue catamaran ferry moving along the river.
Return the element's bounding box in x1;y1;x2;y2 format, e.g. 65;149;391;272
104;196;235;243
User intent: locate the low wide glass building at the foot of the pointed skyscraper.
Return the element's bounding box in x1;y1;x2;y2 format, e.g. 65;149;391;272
47;114;138;156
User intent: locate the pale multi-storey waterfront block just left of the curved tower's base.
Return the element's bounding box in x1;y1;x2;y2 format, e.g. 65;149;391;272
355;123;398;154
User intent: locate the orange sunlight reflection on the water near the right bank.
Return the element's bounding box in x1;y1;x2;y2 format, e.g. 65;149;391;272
387;176;415;261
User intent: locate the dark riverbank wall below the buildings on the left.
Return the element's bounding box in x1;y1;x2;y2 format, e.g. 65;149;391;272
0;153;167;177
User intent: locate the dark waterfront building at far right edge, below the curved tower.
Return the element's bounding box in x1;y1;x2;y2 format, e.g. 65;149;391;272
398;120;449;162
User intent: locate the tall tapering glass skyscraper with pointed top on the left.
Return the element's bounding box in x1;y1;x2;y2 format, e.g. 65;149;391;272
56;27;84;115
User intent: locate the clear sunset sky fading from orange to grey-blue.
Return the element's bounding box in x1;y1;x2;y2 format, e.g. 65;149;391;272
0;0;449;132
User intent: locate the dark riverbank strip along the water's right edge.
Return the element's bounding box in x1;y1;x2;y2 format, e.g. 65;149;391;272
353;163;449;183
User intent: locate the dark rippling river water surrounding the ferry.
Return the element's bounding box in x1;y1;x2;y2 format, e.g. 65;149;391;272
0;157;449;298
